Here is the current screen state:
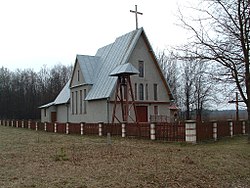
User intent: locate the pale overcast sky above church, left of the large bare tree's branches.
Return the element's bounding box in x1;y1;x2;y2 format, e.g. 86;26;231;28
0;0;193;71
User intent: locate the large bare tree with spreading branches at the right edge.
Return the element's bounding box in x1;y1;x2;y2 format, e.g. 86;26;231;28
180;0;250;141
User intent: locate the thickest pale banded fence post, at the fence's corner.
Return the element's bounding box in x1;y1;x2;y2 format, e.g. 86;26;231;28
185;120;197;144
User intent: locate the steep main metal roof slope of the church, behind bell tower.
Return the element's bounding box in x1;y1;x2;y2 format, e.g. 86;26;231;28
86;28;143;100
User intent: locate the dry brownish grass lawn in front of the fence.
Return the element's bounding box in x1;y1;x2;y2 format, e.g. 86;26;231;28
0;126;250;188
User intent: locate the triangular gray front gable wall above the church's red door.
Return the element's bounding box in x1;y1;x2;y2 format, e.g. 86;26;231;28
129;32;173;102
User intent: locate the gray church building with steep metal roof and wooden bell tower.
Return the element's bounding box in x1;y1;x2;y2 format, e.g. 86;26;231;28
39;28;176;123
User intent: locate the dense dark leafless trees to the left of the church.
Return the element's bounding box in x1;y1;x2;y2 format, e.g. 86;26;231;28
0;64;72;119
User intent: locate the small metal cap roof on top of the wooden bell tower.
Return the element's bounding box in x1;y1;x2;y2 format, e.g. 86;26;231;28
109;63;139;76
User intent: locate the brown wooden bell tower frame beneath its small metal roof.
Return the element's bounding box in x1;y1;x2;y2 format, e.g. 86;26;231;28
112;73;138;123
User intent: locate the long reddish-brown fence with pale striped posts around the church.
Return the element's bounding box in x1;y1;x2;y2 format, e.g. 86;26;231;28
0;120;248;143
